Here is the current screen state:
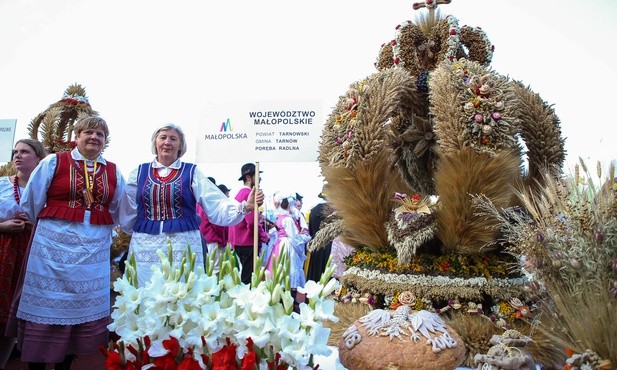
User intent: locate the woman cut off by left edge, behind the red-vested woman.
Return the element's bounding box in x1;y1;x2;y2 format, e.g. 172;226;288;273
0;139;47;369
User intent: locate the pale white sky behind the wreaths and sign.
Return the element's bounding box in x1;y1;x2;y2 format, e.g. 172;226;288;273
0;0;617;205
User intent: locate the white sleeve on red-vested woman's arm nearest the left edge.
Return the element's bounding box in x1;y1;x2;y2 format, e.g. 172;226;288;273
20;154;58;222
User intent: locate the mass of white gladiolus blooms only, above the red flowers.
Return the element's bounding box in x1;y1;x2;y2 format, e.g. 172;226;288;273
108;241;338;369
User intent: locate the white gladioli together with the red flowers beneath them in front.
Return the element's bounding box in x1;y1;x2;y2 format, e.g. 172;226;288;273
101;246;338;370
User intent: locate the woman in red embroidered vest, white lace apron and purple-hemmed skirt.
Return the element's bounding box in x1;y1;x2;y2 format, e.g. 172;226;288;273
7;117;124;370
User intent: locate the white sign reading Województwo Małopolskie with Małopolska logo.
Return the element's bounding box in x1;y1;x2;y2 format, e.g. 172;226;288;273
195;101;325;163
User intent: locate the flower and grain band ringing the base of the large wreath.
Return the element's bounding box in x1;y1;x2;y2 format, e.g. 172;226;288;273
340;246;529;309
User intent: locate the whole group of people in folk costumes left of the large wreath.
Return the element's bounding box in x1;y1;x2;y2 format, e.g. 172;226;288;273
0;116;336;370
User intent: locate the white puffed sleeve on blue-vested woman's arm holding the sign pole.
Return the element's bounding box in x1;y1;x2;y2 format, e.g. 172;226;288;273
192;168;246;226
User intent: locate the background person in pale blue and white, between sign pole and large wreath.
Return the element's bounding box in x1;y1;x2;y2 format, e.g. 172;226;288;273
266;198;311;290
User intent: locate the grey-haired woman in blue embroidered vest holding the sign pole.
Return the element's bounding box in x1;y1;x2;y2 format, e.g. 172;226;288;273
122;123;263;286
